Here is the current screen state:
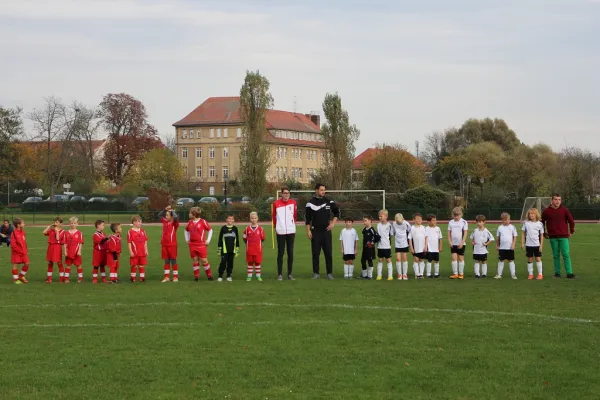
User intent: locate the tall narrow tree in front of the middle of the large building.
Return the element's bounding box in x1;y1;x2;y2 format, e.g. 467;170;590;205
239;71;273;199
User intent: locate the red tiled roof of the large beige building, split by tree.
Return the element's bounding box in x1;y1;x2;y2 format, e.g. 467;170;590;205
173;97;321;133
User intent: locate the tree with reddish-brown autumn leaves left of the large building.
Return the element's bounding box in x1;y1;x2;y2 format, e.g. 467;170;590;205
98;93;162;184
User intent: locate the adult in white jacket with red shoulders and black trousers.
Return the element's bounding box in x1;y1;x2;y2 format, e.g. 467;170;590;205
273;187;298;281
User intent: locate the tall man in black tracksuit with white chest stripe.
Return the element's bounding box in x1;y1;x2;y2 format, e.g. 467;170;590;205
306;184;340;279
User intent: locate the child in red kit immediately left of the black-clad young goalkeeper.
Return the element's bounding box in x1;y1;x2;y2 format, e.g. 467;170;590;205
184;207;213;282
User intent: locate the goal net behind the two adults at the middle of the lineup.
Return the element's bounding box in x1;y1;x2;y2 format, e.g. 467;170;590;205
275;190;385;222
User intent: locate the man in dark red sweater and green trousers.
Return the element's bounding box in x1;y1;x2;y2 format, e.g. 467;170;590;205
542;194;577;279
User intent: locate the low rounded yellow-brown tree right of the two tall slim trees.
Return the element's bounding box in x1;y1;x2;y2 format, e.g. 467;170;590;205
363;144;425;193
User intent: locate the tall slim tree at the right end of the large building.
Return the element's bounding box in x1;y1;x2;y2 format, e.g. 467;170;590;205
321;93;360;190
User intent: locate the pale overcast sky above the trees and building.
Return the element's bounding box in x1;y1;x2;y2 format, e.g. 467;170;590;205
0;0;600;152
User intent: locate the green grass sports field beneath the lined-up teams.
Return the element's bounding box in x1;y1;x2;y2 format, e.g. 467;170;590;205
0;224;600;399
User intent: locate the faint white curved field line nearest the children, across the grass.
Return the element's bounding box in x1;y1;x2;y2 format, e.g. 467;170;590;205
0;301;598;324
